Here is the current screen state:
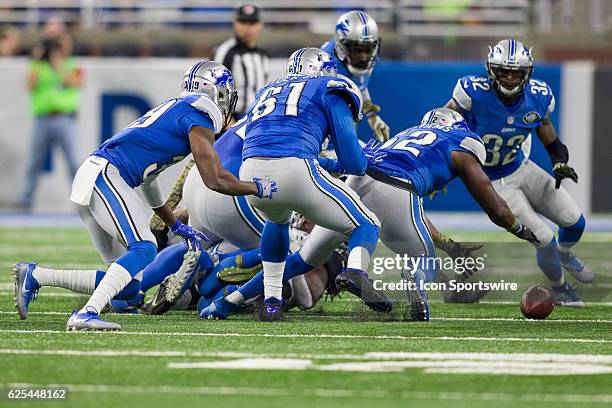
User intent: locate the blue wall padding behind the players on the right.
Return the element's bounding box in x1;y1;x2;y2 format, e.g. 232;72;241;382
359;61;561;211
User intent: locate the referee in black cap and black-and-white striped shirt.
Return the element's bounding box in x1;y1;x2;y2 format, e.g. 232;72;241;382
213;4;268;120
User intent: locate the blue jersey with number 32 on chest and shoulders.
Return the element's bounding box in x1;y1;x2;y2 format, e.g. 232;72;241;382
453;76;555;180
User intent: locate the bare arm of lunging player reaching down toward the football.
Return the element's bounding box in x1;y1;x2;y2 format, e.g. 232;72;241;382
451;151;539;244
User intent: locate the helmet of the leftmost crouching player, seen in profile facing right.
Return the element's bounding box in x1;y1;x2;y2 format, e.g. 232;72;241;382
181;60;238;130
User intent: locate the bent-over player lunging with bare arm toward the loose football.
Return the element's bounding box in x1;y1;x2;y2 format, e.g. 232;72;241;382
200;108;538;320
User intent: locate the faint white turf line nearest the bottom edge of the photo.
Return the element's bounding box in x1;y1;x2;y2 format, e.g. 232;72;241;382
0;383;612;403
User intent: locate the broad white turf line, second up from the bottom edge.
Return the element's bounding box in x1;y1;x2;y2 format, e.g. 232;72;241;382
0;349;612;364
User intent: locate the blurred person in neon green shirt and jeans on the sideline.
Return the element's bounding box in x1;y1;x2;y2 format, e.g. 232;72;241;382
21;23;82;211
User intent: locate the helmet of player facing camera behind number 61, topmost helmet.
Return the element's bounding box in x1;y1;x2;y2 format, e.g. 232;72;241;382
334;10;380;75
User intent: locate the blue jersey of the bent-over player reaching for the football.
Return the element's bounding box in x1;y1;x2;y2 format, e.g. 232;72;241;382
372;125;486;197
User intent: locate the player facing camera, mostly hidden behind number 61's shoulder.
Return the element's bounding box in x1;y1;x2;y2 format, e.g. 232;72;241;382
321;10;390;142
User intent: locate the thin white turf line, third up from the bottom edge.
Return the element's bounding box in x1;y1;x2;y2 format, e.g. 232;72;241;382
0;329;612;344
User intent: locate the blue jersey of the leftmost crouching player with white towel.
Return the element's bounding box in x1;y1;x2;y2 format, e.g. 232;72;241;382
93;94;223;188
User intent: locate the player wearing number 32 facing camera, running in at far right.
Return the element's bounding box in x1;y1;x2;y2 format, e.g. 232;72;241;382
446;38;594;307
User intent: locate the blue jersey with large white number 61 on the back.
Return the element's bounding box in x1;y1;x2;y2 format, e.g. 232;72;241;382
242;75;361;160
